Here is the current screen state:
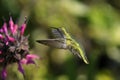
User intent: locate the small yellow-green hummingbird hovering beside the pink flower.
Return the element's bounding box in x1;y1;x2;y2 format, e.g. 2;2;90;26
37;27;89;64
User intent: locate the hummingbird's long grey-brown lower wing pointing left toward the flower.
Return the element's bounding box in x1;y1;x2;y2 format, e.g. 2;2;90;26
37;38;66;49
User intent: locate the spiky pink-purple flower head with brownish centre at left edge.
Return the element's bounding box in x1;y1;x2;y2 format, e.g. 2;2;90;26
0;17;39;80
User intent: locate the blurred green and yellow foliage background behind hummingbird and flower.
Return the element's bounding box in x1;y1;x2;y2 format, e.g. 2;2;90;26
0;0;120;80
